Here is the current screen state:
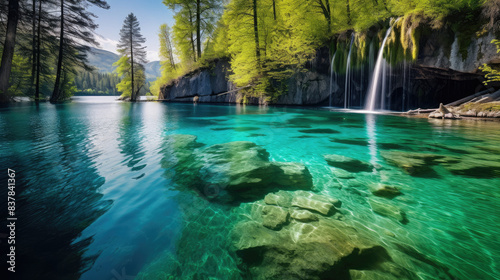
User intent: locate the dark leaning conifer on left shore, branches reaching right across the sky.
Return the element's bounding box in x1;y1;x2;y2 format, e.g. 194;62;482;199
50;0;109;102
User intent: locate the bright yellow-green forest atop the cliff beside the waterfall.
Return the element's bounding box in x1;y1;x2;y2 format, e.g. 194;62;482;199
151;0;500;99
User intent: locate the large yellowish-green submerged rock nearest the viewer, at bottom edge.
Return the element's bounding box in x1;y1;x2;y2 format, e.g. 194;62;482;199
229;191;415;279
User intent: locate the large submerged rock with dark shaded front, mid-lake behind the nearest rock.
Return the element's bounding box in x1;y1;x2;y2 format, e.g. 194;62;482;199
198;141;313;200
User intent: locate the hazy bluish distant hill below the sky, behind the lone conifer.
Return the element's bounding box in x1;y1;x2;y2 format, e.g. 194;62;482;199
87;47;161;81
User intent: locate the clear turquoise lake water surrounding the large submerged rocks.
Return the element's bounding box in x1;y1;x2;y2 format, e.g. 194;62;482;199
0;97;500;279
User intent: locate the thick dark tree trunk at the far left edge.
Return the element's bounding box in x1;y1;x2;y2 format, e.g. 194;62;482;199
0;0;19;102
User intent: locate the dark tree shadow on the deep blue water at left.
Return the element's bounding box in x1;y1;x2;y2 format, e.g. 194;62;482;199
0;105;112;279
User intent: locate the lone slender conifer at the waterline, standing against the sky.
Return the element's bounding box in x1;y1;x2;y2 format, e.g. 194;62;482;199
117;13;146;102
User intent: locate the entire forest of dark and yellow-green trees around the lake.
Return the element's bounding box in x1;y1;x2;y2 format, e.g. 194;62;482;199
0;0;500;102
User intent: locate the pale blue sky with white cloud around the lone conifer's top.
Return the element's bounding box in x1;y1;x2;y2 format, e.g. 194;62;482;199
90;0;174;61
